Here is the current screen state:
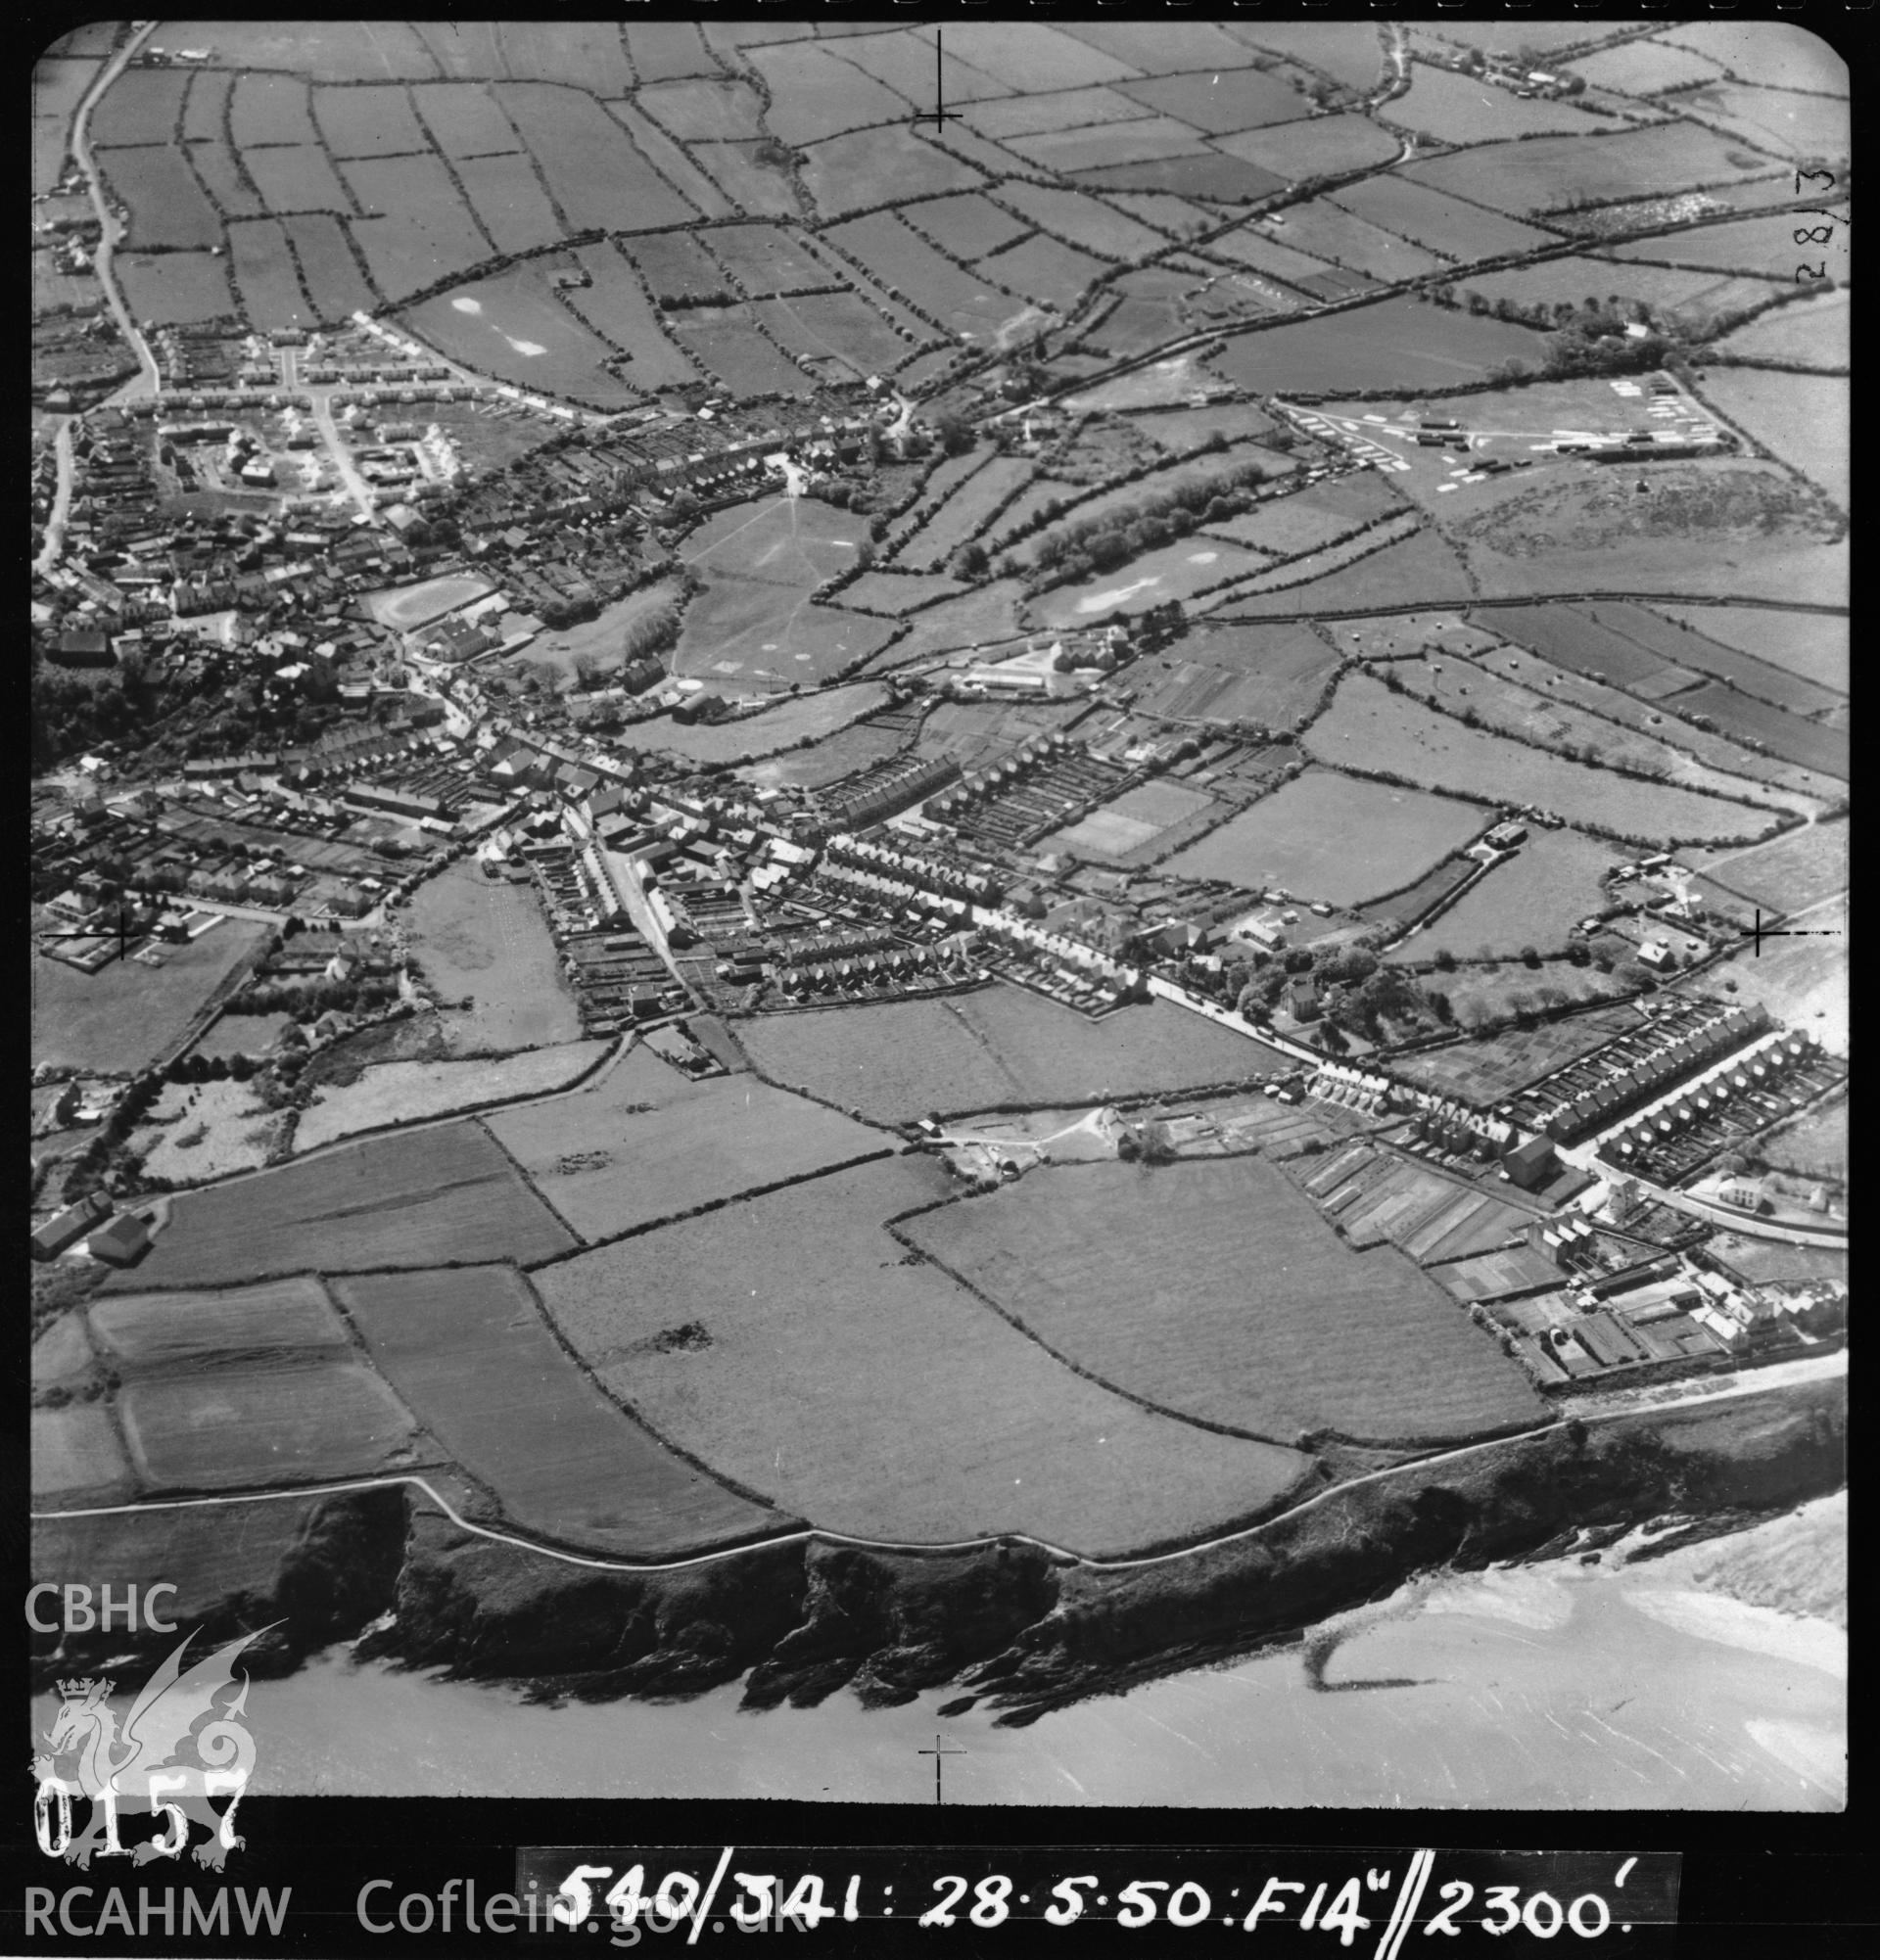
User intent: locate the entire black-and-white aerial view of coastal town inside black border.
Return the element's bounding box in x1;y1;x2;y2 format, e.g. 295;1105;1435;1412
29;0;1853;1857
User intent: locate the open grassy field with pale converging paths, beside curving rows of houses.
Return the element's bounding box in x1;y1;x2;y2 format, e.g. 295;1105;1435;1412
675;498;892;694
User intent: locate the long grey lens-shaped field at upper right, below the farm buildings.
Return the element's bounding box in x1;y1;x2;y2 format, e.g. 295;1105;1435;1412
1403;122;1772;213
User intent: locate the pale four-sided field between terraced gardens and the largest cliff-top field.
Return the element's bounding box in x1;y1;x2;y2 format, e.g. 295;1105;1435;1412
485;1047;896;1244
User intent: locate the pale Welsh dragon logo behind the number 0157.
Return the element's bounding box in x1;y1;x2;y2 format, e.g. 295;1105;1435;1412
33;1627;266;1872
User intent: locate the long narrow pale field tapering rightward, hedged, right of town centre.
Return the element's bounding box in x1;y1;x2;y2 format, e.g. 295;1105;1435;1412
1301;675;1772;847
